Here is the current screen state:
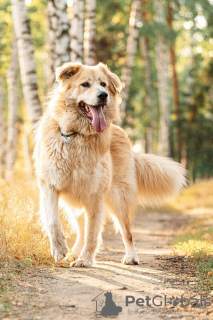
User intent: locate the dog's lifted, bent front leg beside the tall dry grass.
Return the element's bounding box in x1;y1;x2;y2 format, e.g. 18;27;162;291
39;181;68;261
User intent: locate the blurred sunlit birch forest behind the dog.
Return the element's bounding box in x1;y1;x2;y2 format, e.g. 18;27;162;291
0;0;213;182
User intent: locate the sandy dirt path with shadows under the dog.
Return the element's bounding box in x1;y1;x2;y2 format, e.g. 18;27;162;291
2;213;213;320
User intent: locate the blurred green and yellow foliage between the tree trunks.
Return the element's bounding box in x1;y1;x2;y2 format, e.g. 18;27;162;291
0;0;213;181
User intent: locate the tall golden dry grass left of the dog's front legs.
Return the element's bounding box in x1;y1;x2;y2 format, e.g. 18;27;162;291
0;180;75;267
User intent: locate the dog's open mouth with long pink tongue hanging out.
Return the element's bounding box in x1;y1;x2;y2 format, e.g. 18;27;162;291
79;101;106;132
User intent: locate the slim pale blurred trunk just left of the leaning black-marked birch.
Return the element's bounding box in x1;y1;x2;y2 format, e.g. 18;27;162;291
5;34;18;182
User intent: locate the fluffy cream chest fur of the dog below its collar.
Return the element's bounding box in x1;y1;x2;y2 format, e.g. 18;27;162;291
41;137;112;206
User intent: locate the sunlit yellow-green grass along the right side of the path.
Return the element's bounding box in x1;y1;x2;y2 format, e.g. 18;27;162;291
168;181;213;293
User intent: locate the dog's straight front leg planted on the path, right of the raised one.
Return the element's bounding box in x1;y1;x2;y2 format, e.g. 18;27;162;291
70;200;105;267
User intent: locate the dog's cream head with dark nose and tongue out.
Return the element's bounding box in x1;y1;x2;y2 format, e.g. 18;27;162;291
56;63;121;133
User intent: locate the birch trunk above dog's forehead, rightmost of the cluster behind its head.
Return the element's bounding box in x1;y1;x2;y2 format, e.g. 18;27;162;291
84;0;96;66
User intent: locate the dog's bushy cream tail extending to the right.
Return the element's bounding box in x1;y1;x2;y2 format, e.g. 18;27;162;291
135;153;187;207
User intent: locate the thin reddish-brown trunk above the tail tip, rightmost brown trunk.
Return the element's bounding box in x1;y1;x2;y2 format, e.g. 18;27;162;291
167;3;182;163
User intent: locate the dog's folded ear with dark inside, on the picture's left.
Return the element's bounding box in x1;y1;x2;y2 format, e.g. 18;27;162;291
56;62;82;82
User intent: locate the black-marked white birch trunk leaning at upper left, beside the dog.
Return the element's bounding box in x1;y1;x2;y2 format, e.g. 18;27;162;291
12;0;42;126
